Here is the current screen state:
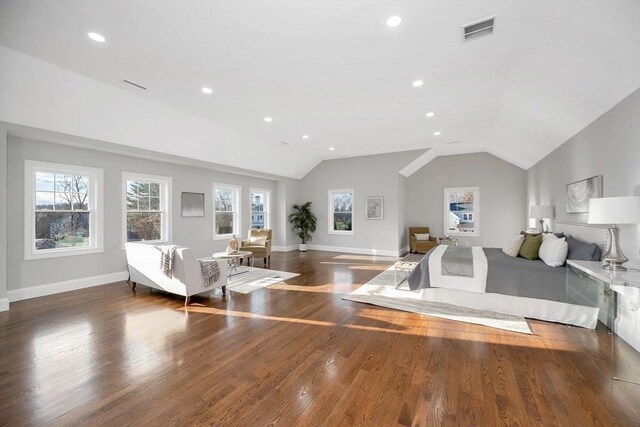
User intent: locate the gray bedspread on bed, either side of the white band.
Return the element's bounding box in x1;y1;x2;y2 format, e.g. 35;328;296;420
408;248;566;302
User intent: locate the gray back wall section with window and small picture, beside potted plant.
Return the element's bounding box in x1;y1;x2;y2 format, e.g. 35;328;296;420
299;150;424;253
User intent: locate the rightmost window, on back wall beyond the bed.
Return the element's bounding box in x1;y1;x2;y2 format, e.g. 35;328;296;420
444;187;480;236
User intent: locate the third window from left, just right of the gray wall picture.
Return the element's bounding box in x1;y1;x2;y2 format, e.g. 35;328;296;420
213;184;240;239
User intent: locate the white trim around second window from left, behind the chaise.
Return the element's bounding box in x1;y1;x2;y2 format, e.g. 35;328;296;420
121;172;173;249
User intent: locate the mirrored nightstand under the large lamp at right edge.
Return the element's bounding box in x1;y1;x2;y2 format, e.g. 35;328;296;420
566;260;640;386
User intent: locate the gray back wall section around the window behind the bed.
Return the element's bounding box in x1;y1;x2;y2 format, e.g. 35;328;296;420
404;153;527;247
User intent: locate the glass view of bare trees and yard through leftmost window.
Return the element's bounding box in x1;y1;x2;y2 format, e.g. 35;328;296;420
35;172;91;250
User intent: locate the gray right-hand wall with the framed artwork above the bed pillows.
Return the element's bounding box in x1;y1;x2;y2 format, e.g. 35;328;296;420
527;90;640;260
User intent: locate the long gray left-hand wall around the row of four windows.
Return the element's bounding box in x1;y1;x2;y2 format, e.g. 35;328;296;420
5;136;278;289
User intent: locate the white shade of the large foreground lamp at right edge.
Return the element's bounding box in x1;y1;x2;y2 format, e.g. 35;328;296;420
587;196;640;224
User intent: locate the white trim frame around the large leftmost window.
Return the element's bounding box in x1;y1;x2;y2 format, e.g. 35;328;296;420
24;160;104;261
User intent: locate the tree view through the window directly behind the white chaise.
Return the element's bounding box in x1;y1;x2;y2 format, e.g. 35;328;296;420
127;180;162;242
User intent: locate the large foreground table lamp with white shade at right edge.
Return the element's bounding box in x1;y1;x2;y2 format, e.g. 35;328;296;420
587;196;640;271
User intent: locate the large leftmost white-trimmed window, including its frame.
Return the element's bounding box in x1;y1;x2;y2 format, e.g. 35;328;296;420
25;160;103;260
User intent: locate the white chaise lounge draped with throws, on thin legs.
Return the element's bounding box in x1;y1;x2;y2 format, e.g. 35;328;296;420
124;243;228;305
